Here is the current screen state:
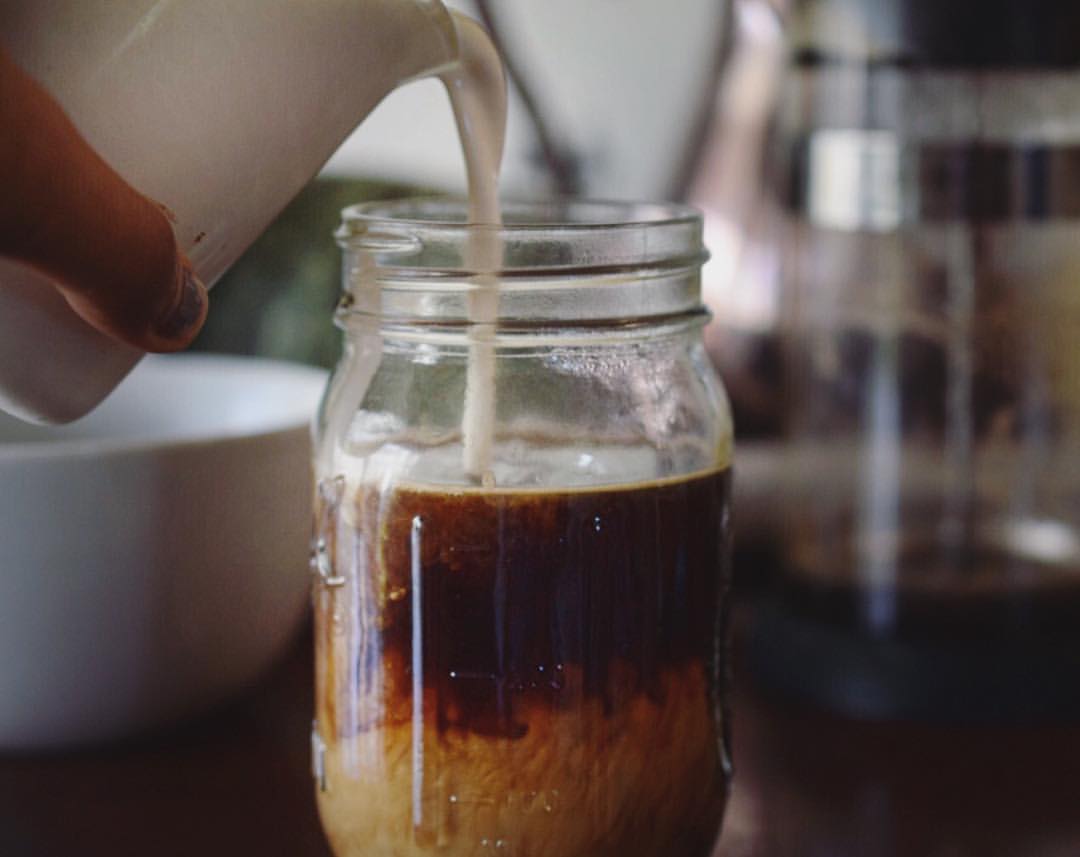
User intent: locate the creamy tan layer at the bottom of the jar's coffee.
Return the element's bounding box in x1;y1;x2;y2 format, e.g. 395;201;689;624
319;665;727;857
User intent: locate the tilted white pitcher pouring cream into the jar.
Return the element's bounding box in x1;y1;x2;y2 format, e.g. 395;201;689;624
0;0;457;422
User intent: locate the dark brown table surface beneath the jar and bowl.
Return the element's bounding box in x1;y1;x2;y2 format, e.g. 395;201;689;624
0;613;1080;857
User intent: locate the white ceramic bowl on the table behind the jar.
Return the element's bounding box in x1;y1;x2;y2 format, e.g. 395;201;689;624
0;356;325;748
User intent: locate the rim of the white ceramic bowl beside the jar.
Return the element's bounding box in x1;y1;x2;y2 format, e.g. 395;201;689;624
0;353;329;464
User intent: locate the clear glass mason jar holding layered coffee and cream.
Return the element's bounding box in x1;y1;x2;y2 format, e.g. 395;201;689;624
312;201;732;857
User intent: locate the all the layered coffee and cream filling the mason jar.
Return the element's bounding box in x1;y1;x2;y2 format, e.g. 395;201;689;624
316;470;730;857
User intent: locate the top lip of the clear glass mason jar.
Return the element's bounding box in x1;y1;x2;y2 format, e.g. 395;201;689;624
335;196;702;240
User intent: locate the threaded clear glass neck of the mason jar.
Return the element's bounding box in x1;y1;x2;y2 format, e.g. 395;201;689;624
335;199;707;332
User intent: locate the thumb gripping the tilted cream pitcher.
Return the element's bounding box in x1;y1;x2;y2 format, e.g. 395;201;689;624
0;51;207;351
